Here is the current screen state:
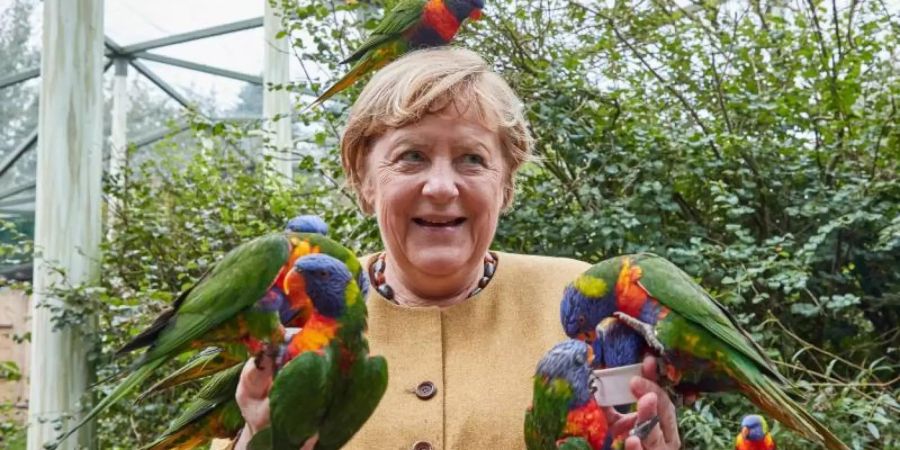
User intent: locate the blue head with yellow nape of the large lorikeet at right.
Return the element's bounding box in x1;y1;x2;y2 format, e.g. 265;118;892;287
559;275;616;342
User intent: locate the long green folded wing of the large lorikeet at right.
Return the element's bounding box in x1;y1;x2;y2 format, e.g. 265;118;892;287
635;253;790;385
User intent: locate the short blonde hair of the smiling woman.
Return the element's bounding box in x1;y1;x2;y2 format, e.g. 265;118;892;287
341;47;532;214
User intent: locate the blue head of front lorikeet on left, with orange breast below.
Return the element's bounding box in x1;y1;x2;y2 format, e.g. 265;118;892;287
294;253;353;318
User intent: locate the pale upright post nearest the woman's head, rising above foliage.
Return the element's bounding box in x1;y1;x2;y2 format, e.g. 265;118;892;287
263;0;294;182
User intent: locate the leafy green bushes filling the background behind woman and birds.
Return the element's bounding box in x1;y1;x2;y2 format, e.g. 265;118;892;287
1;0;900;449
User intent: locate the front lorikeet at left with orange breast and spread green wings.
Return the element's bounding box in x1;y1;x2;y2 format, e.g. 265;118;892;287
250;255;387;450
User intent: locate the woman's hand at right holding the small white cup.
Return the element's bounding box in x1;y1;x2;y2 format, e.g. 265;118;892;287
607;356;681;450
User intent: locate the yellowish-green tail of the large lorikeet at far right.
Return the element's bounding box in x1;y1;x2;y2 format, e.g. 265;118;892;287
742;373;850;450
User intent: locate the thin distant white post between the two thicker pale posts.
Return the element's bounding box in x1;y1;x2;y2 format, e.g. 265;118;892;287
106;58;130;239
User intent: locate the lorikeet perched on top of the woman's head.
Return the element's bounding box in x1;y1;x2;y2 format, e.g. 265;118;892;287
309;0;484;108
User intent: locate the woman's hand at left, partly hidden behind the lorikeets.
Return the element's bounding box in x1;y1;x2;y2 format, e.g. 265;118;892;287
234;356;316;450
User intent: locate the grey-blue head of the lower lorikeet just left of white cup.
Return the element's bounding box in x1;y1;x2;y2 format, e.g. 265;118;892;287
535;339;592;409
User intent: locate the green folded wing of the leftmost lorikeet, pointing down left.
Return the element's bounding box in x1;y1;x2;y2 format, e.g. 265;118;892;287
142;233;290;360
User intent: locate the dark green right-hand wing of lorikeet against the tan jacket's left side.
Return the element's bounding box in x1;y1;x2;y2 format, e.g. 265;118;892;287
315;356;388;450
